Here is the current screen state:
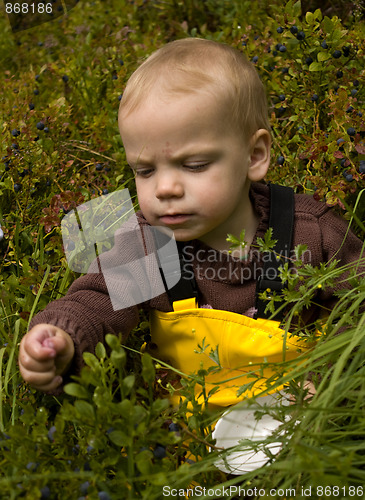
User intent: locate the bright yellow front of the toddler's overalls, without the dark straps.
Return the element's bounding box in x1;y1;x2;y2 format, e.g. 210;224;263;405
150;298;306;406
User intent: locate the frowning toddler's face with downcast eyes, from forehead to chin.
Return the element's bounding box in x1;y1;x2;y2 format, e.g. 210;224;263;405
120;89;268;250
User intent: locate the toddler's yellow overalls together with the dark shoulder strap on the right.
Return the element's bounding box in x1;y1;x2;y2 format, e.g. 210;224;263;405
150;185;306;406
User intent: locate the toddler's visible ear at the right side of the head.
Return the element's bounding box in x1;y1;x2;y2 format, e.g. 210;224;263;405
247;128;271;181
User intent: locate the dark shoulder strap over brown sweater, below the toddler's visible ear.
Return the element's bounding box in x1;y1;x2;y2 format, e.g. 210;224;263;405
255;184;294;320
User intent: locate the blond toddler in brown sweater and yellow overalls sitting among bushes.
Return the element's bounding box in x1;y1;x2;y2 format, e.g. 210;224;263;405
19;38;362;405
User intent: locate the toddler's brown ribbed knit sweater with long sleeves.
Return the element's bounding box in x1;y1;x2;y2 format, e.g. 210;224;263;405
30;183;362;384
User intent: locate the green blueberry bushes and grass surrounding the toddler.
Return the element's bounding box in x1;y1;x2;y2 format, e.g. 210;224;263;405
0;0;365;500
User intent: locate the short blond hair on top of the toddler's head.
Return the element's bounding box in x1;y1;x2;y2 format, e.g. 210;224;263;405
119;38;270;138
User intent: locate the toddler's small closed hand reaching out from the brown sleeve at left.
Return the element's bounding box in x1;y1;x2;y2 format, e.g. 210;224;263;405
19;323;75;392
